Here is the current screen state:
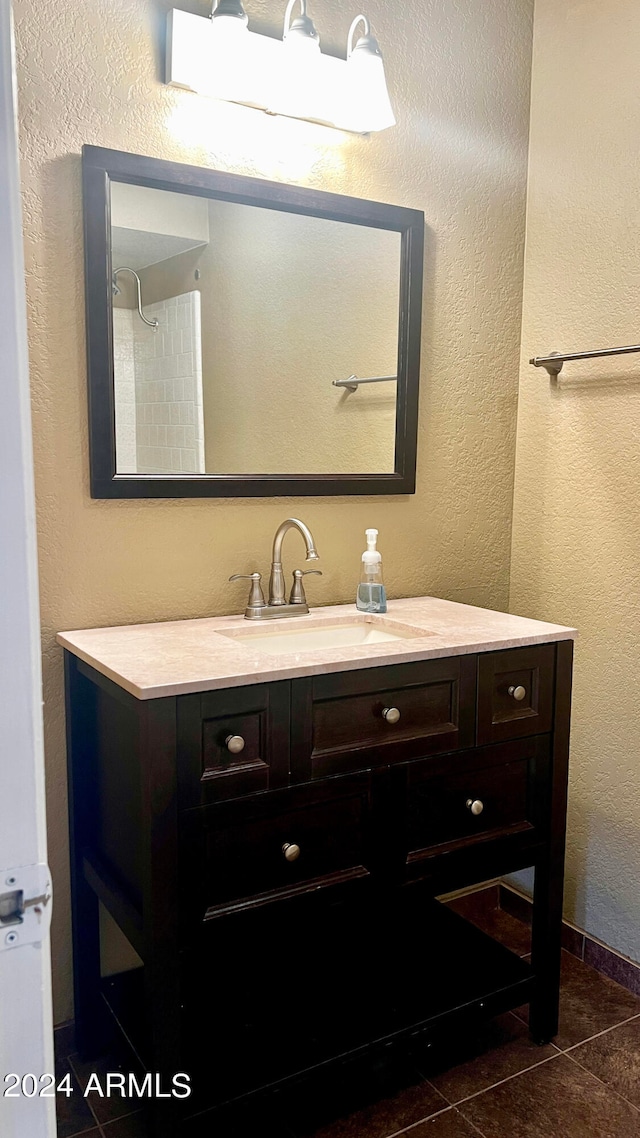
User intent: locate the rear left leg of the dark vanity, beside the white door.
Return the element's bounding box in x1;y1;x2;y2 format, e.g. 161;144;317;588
65;652;109;1059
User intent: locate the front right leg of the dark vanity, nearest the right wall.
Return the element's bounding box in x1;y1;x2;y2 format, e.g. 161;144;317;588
530;641;573;1044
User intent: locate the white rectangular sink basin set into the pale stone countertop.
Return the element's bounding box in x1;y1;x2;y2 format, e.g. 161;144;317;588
221;617;430;655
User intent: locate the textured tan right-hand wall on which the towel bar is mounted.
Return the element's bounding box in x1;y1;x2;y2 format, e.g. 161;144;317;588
510;0;640;960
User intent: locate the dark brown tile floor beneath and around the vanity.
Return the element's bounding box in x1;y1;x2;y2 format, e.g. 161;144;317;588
56;890;640;1138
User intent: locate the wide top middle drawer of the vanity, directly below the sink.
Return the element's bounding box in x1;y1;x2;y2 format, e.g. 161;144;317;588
292;655;476;781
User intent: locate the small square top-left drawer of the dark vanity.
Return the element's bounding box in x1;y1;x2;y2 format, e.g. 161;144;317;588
178;683;289;809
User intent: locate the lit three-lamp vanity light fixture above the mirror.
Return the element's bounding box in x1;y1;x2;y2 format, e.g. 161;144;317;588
166;0;395;134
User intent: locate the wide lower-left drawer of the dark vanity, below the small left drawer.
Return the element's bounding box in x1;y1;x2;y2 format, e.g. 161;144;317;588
183;774;370;921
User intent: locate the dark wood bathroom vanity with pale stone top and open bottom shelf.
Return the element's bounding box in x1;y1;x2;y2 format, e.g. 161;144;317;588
58;597;574;1136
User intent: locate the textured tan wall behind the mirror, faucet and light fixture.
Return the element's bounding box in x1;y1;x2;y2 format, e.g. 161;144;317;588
16;0;532;1019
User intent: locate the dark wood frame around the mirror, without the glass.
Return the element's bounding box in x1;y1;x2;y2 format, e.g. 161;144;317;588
82;146;425;498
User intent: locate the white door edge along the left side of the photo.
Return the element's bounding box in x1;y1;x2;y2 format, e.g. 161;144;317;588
0;0;56;1138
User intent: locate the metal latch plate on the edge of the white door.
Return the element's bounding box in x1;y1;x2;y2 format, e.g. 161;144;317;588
0;861;52;953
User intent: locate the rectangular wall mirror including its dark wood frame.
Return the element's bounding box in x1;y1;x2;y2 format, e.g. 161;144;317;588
83;147;424;497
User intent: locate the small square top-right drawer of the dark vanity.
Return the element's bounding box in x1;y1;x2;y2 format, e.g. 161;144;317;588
477;644;556;743
